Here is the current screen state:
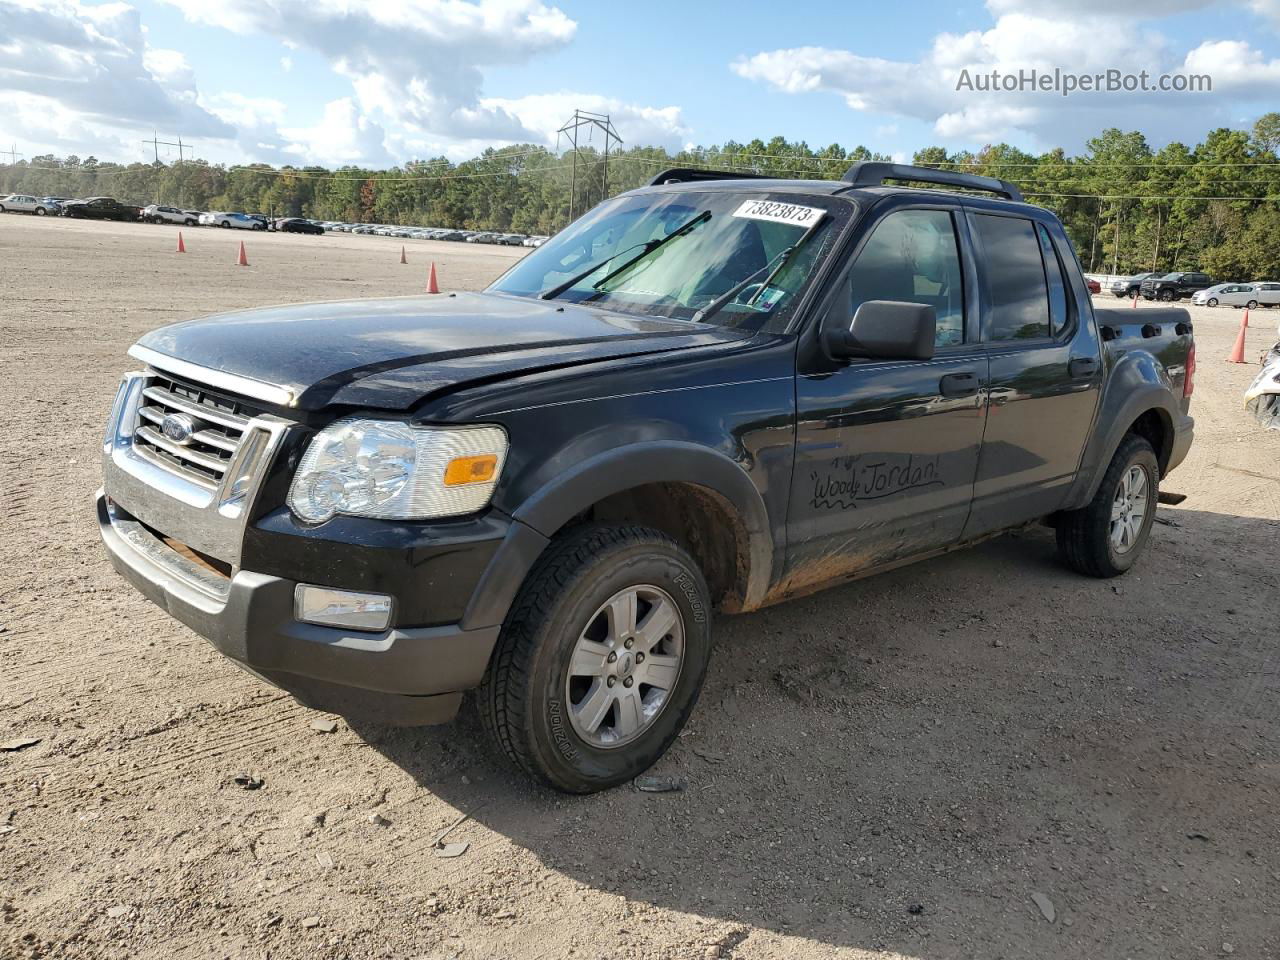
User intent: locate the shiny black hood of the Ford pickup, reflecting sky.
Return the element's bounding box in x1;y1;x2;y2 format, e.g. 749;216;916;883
138;293;742;411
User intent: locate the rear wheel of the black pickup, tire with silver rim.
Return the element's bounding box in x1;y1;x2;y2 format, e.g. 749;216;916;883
1057;434;1160;577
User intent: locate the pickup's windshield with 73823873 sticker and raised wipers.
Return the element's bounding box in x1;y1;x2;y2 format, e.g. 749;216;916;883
489;189;854;329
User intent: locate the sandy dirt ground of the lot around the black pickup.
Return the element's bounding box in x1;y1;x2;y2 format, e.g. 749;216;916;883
0;215;1280;960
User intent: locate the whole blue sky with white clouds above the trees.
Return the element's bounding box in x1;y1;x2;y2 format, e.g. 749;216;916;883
0;0;1280;165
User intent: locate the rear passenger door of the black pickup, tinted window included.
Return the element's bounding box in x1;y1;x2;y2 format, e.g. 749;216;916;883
964;209;1102;539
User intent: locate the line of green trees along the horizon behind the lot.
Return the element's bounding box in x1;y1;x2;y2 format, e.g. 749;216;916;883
0;113;1280;279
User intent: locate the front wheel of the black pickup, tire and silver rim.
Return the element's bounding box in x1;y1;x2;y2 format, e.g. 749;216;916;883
477;525;712;794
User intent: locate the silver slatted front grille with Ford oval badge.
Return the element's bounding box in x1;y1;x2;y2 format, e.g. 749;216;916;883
133;374;260;490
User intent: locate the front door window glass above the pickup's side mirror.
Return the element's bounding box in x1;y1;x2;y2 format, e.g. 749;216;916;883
850;210;964;347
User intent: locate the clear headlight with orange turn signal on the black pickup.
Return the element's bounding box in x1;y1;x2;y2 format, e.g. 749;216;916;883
289;419;507;524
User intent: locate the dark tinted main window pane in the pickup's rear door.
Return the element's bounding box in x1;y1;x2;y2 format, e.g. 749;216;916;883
973;214;1049;340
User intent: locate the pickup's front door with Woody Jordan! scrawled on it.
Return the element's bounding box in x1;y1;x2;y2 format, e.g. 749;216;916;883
786;204;987;593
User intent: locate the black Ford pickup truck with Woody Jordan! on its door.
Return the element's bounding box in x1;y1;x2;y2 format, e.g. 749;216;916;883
97;163;1194;792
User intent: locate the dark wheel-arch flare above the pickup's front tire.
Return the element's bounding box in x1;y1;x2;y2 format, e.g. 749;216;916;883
513;440;774;609
